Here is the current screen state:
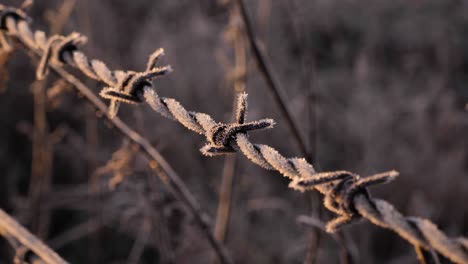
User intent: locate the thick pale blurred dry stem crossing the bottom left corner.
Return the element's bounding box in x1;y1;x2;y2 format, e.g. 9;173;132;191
0;209;67;264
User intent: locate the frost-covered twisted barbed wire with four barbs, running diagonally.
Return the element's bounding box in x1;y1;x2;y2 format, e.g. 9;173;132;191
0;5;468;263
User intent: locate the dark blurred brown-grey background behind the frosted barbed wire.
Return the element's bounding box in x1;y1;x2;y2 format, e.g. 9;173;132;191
0;0;468;263
